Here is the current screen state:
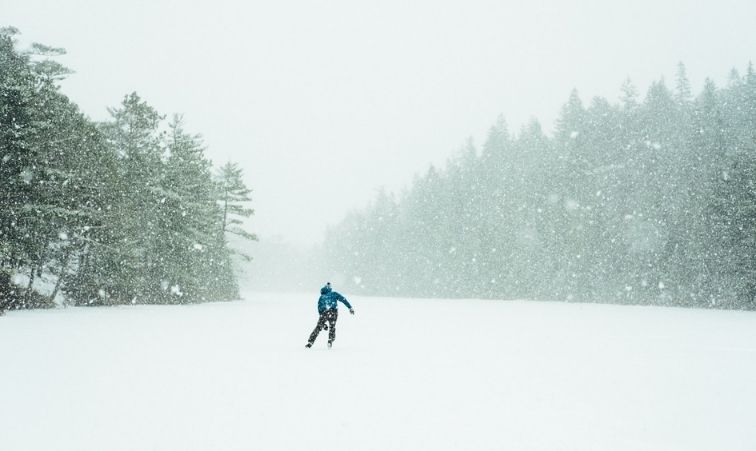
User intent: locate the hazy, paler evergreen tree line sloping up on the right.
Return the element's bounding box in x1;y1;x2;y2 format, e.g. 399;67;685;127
324;64;756;309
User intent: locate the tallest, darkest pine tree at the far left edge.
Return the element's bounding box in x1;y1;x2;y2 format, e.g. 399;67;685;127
0;29;109;306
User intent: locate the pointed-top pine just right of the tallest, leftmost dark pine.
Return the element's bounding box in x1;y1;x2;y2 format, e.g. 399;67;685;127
85;93;165;303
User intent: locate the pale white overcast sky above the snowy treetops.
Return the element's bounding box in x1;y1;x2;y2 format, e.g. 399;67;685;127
5;0;756;244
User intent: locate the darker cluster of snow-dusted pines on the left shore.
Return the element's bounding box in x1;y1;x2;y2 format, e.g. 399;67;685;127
0;27;255;311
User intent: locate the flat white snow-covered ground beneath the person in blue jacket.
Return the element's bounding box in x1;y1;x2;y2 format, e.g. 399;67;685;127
0;293;756;451
